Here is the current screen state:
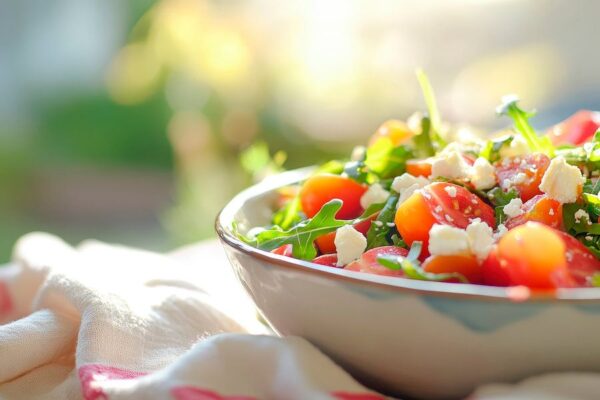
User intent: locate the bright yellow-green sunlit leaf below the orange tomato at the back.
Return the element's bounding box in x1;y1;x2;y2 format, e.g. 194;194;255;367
365;138;414;178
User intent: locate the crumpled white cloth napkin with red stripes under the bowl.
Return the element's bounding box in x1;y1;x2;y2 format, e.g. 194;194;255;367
0;233;600;400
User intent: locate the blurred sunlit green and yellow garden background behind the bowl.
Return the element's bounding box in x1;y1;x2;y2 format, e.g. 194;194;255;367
0;0;600;261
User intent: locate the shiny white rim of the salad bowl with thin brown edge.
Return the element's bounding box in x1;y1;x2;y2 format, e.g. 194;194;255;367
215;167;600;303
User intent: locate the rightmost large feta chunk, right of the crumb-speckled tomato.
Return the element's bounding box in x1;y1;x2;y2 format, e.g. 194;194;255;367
540;157;585;203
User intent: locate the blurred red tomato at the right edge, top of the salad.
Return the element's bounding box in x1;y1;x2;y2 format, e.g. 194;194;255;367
548;110;600;146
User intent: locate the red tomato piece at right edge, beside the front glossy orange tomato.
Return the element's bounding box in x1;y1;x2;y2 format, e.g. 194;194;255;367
557;232;600;286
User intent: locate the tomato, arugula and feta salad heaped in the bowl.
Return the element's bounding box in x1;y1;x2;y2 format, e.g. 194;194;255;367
236;73;600;289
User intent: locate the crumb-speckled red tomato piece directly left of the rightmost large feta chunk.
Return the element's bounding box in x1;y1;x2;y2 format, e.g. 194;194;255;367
496;153;550;201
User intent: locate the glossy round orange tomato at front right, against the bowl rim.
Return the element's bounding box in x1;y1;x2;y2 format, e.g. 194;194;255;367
498;222;571;289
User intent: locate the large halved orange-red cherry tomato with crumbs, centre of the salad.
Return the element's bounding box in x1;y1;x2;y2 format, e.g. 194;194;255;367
394;182;496;257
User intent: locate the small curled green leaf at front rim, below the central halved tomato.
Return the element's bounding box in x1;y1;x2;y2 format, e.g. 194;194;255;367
377;241;469;283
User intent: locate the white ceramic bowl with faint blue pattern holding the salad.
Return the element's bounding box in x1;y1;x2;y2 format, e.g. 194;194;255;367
216;170;600;399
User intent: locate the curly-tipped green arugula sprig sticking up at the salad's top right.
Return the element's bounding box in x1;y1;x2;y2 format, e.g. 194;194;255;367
496;95;554;157
